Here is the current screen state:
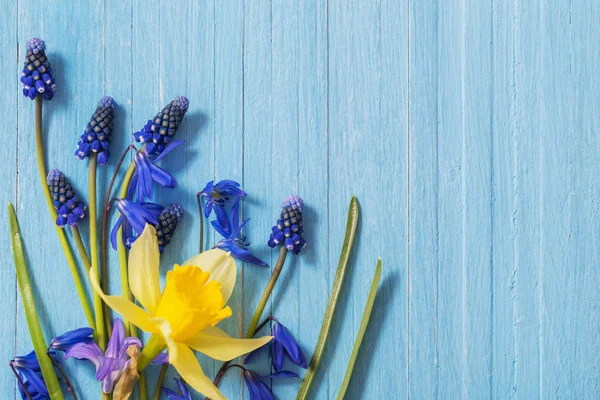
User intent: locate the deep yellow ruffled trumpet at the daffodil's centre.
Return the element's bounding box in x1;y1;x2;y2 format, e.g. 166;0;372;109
156;265;231;342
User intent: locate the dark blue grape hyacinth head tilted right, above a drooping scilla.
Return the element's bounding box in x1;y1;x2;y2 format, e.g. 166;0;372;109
133;96;189;155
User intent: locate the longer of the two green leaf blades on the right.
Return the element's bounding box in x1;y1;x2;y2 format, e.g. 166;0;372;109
296;196;358;400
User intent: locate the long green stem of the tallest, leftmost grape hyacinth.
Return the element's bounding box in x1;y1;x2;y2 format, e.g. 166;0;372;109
35;97;95;329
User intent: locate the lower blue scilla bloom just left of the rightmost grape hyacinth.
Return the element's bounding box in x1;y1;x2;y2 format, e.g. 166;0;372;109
211;197;268;267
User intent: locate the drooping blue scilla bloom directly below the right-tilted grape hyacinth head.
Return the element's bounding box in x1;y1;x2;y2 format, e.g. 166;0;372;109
128;140;184;201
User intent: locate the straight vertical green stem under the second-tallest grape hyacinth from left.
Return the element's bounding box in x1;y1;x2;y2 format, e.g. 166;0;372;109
88;153;106;350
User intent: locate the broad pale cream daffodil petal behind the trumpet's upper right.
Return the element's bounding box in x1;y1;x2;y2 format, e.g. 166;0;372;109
182;249;237;302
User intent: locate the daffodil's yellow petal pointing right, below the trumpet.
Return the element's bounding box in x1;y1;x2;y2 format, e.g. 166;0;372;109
186;326;273;361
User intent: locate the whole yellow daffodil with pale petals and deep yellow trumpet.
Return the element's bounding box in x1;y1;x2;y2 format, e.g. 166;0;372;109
90;225;272;400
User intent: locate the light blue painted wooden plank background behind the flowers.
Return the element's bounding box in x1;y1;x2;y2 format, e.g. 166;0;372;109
0;0;600;399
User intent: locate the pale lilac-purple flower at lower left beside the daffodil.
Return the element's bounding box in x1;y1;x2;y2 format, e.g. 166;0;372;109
65;318;142;394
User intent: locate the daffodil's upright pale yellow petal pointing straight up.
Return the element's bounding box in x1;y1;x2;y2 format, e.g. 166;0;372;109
128;225;161;314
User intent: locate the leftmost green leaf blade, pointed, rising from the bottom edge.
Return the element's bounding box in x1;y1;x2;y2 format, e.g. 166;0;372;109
8;203;64;400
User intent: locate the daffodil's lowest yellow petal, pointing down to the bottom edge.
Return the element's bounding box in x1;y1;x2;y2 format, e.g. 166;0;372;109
167;338;227;400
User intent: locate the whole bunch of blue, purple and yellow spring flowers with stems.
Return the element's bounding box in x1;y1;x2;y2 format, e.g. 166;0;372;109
9;39;382;400
